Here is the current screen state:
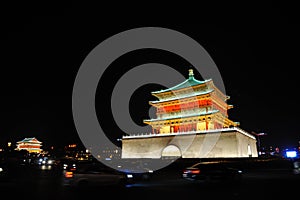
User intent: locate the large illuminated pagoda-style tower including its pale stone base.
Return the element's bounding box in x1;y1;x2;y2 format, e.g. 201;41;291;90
121;69;258;160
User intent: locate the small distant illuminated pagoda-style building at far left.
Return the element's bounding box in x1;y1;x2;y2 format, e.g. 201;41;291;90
16;137;43;153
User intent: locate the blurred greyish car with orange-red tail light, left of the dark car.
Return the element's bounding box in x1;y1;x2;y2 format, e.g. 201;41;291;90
63;163;132;189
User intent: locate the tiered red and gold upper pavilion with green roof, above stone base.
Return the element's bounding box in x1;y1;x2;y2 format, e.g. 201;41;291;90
144;69;239;134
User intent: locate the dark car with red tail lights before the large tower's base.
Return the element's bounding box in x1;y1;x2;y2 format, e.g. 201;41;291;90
182;162;243;182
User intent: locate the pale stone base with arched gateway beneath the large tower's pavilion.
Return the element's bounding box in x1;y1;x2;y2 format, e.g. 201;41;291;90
121;127;258;159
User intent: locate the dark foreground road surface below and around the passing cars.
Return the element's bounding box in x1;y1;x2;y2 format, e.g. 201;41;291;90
0;159;300;200
